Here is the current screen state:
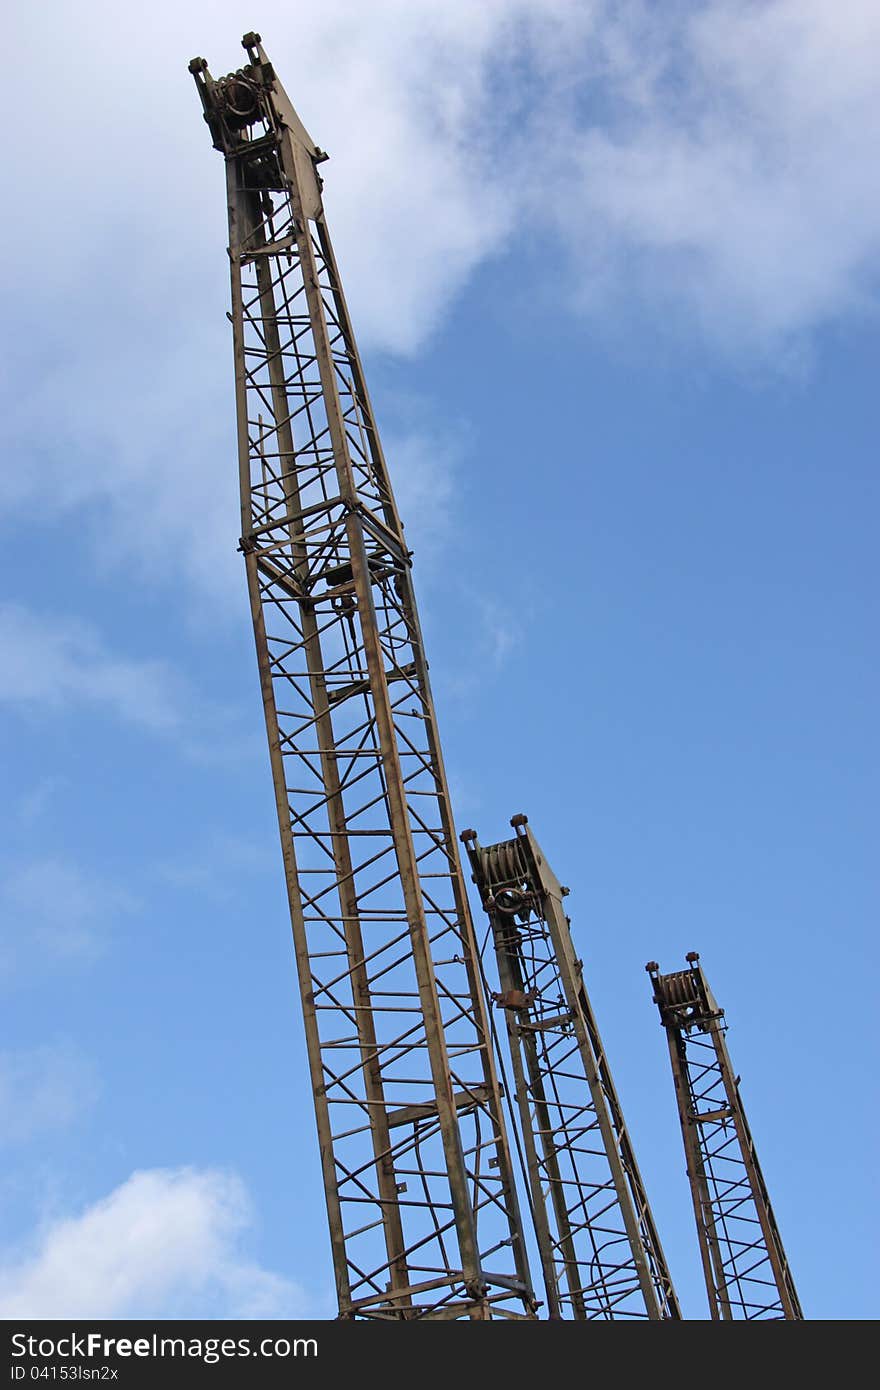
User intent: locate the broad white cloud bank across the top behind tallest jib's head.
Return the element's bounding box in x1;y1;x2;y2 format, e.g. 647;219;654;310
0;0;880;603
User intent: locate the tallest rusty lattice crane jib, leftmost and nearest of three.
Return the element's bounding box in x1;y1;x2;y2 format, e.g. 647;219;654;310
189;33;535;1319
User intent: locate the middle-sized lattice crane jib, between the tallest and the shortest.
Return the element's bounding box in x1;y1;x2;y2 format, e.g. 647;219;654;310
462;816;681;1319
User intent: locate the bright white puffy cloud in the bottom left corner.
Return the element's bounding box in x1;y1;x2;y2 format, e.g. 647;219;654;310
0;1168;304;1319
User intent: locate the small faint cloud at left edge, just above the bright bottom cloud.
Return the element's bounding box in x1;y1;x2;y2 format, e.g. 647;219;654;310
0;1044;99;1144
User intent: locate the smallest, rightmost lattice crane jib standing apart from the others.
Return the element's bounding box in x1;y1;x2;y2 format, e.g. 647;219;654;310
646;951;804;1321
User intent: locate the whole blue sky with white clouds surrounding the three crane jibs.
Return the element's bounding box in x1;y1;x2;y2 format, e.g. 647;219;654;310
0;0;880;1319
